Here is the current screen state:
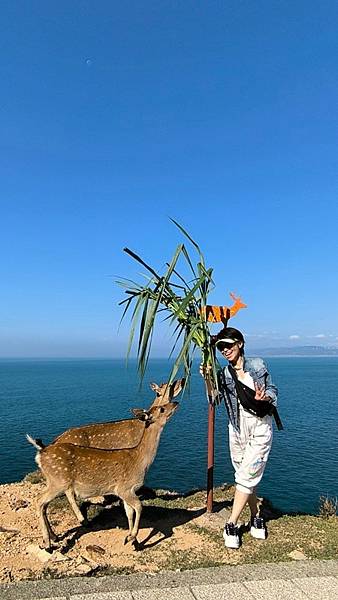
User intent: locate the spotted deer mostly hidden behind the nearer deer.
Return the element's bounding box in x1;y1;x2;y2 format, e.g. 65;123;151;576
47;379;185;449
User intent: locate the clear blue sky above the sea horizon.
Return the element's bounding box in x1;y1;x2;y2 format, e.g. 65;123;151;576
0;0;338;357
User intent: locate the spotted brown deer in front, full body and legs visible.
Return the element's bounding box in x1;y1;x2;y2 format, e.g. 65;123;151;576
27;402;178;549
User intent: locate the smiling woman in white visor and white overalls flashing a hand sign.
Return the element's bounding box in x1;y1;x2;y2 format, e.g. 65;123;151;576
201;327;277;548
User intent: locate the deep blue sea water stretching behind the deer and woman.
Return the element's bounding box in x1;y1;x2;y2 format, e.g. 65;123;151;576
0;357;338;513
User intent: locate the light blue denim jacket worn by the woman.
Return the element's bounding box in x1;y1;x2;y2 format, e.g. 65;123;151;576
218;357;277;431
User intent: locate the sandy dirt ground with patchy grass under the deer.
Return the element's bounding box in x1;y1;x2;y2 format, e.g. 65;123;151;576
0;477;338;582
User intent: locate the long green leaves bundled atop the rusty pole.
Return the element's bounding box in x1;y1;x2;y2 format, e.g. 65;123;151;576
118;219;217;398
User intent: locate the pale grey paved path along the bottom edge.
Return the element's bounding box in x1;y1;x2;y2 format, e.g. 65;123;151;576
0;560;338;600
